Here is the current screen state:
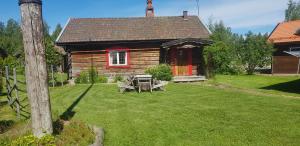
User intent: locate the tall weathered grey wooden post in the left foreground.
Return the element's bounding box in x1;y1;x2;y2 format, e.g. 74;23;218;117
19;0;53;137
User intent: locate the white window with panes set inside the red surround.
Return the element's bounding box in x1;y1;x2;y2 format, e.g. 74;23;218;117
109;50;128;66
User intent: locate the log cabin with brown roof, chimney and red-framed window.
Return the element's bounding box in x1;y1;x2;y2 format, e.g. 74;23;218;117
56;0;211;78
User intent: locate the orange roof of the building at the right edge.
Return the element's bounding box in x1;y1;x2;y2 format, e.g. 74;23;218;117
269;20;300;44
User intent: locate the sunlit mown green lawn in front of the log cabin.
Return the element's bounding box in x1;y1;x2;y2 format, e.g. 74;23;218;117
0;76;300;146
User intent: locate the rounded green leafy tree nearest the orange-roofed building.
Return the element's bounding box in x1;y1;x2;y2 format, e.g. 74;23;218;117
239;32;273;74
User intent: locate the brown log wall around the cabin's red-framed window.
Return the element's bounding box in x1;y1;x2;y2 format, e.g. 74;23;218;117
71;48;160;77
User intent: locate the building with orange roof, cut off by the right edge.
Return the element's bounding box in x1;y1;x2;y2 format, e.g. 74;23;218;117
268;20;300;74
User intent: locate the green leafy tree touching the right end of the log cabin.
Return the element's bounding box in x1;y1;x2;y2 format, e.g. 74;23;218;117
204;21;240;76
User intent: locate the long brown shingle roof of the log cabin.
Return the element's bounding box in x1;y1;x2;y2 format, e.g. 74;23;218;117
57;16;209;44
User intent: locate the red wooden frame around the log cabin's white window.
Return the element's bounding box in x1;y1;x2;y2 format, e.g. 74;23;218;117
106;47;130;68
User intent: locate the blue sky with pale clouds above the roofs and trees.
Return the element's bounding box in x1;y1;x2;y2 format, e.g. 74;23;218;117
0;0;288;34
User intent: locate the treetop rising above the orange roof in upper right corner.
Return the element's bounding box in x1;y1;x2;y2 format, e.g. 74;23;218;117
285;0;300;21
